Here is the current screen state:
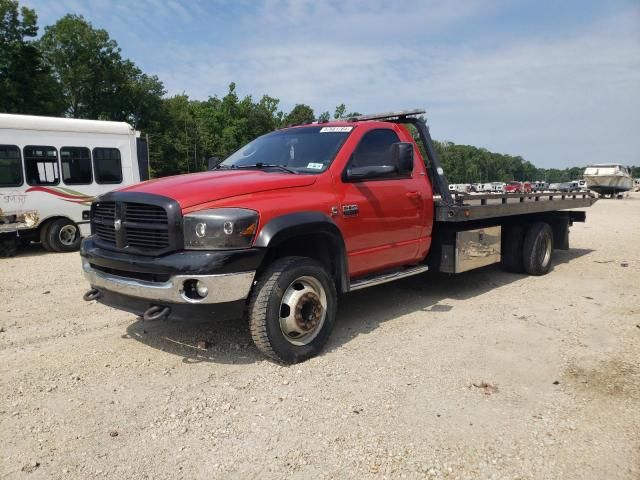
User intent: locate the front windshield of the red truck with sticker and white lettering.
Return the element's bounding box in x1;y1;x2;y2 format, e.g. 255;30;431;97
219;126;353;174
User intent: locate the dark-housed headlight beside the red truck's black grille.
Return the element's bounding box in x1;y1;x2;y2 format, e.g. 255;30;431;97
184;208;259;250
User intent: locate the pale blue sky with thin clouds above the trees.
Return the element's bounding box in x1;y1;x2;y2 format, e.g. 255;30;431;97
21;0;640;168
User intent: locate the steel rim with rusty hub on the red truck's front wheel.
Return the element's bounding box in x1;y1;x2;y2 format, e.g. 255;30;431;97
279;276;327;345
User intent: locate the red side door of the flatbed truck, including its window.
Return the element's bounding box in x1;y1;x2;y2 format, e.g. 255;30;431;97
336;128;431;276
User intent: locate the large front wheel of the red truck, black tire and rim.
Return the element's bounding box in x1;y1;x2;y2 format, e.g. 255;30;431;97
248;257;337;364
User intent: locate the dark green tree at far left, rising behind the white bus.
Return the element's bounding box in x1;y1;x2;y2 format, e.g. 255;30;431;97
0;0;63;115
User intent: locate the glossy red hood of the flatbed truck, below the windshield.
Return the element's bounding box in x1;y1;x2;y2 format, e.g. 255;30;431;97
120;170;316;208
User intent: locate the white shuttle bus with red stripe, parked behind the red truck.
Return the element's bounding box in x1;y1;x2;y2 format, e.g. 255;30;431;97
0;114;149;256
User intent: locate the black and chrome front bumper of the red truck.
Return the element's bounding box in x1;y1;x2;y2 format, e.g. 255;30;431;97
80;237;264;305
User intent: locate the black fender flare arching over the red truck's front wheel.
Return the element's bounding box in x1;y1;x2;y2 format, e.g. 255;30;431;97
253;211;349;293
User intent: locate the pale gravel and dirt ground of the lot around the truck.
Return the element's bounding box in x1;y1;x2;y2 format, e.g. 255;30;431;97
0;194;640;480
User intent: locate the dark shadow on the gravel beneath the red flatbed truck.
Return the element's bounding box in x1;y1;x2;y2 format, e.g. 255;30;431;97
126;249;592;364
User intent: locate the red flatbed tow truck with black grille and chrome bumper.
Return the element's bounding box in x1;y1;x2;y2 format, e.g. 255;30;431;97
81;110;596;363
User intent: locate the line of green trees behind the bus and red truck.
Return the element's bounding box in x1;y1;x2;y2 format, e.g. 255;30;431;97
0;0;640;183
